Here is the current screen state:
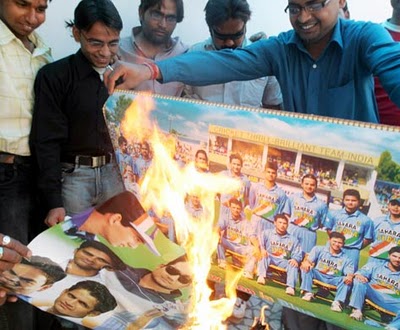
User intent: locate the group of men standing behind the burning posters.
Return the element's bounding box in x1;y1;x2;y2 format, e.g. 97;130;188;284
0;0;399;329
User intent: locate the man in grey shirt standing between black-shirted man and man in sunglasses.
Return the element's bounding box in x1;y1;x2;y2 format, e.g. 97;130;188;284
119;0;188;97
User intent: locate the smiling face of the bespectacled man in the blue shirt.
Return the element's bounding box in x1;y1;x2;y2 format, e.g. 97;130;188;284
288;0;345;47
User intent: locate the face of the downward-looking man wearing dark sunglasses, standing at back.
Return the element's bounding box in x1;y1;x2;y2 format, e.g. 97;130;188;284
210;18;246;50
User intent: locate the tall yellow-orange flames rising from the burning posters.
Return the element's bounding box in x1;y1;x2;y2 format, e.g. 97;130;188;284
121;97;241;329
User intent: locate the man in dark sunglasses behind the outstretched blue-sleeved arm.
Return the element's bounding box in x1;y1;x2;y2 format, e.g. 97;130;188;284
184;0;282;109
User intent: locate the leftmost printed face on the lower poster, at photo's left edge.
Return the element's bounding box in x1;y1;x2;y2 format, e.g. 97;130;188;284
0;264;47;295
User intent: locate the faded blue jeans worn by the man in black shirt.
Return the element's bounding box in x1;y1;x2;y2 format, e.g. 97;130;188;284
61;163;125;216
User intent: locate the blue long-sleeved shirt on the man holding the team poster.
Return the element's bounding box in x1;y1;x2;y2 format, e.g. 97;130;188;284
157;19;400;122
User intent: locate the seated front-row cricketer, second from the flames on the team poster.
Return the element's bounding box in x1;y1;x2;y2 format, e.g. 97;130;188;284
257;214;302;296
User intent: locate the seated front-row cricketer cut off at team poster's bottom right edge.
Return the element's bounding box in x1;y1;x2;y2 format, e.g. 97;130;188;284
349;246;400;329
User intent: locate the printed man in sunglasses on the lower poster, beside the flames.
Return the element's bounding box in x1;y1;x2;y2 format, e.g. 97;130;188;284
115;255;193;304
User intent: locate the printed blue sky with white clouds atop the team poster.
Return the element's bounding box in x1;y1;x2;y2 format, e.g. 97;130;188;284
108;94;400;163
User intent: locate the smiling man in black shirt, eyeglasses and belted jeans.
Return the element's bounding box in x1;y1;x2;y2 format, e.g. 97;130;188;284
31;0;124;226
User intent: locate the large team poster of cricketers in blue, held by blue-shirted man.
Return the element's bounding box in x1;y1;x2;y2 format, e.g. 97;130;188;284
105;91;400;329
